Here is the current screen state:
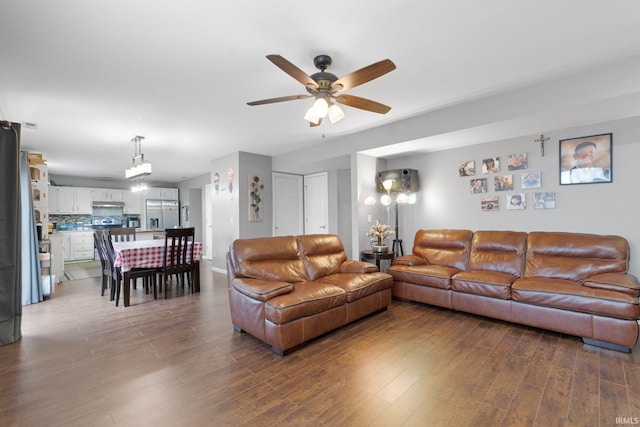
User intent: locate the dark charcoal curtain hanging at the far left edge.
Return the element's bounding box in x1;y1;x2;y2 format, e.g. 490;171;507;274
0;122;22;344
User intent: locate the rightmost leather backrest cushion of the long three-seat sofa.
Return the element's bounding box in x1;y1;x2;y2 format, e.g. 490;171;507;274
524;232;629;282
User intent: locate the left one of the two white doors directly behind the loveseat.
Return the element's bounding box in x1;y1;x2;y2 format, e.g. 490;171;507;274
273;172;304;236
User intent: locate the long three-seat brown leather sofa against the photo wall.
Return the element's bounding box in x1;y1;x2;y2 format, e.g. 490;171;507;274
388;230;640;352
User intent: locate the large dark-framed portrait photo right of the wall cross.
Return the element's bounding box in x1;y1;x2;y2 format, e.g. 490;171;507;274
559;133;613;185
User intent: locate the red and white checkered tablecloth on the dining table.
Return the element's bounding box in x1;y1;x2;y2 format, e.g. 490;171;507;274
113;239;202;272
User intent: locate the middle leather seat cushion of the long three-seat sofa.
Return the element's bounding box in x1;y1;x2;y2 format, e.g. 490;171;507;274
451;270;518;299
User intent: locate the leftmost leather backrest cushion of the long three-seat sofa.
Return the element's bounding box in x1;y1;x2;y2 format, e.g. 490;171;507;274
412;230;473;270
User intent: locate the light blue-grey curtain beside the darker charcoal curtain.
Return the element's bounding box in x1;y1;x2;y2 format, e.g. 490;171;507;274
20;151;43;305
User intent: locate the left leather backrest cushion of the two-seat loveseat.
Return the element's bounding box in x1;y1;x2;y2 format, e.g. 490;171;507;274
229;236;308;283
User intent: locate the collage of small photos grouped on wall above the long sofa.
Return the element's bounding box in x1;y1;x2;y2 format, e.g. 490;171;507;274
458;153;556;211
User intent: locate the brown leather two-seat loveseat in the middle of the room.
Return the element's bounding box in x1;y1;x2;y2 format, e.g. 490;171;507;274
227;234;393;355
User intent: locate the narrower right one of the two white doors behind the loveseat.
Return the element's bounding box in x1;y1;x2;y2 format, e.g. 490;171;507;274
304;172;329;234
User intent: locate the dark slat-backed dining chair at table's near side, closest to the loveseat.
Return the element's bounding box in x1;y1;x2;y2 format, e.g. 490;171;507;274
160;227;197;298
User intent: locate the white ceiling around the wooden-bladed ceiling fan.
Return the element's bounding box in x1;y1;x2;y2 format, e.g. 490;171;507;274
0;0;640;182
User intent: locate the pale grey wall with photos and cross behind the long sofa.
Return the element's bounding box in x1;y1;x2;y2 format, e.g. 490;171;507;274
388;118;640;276
